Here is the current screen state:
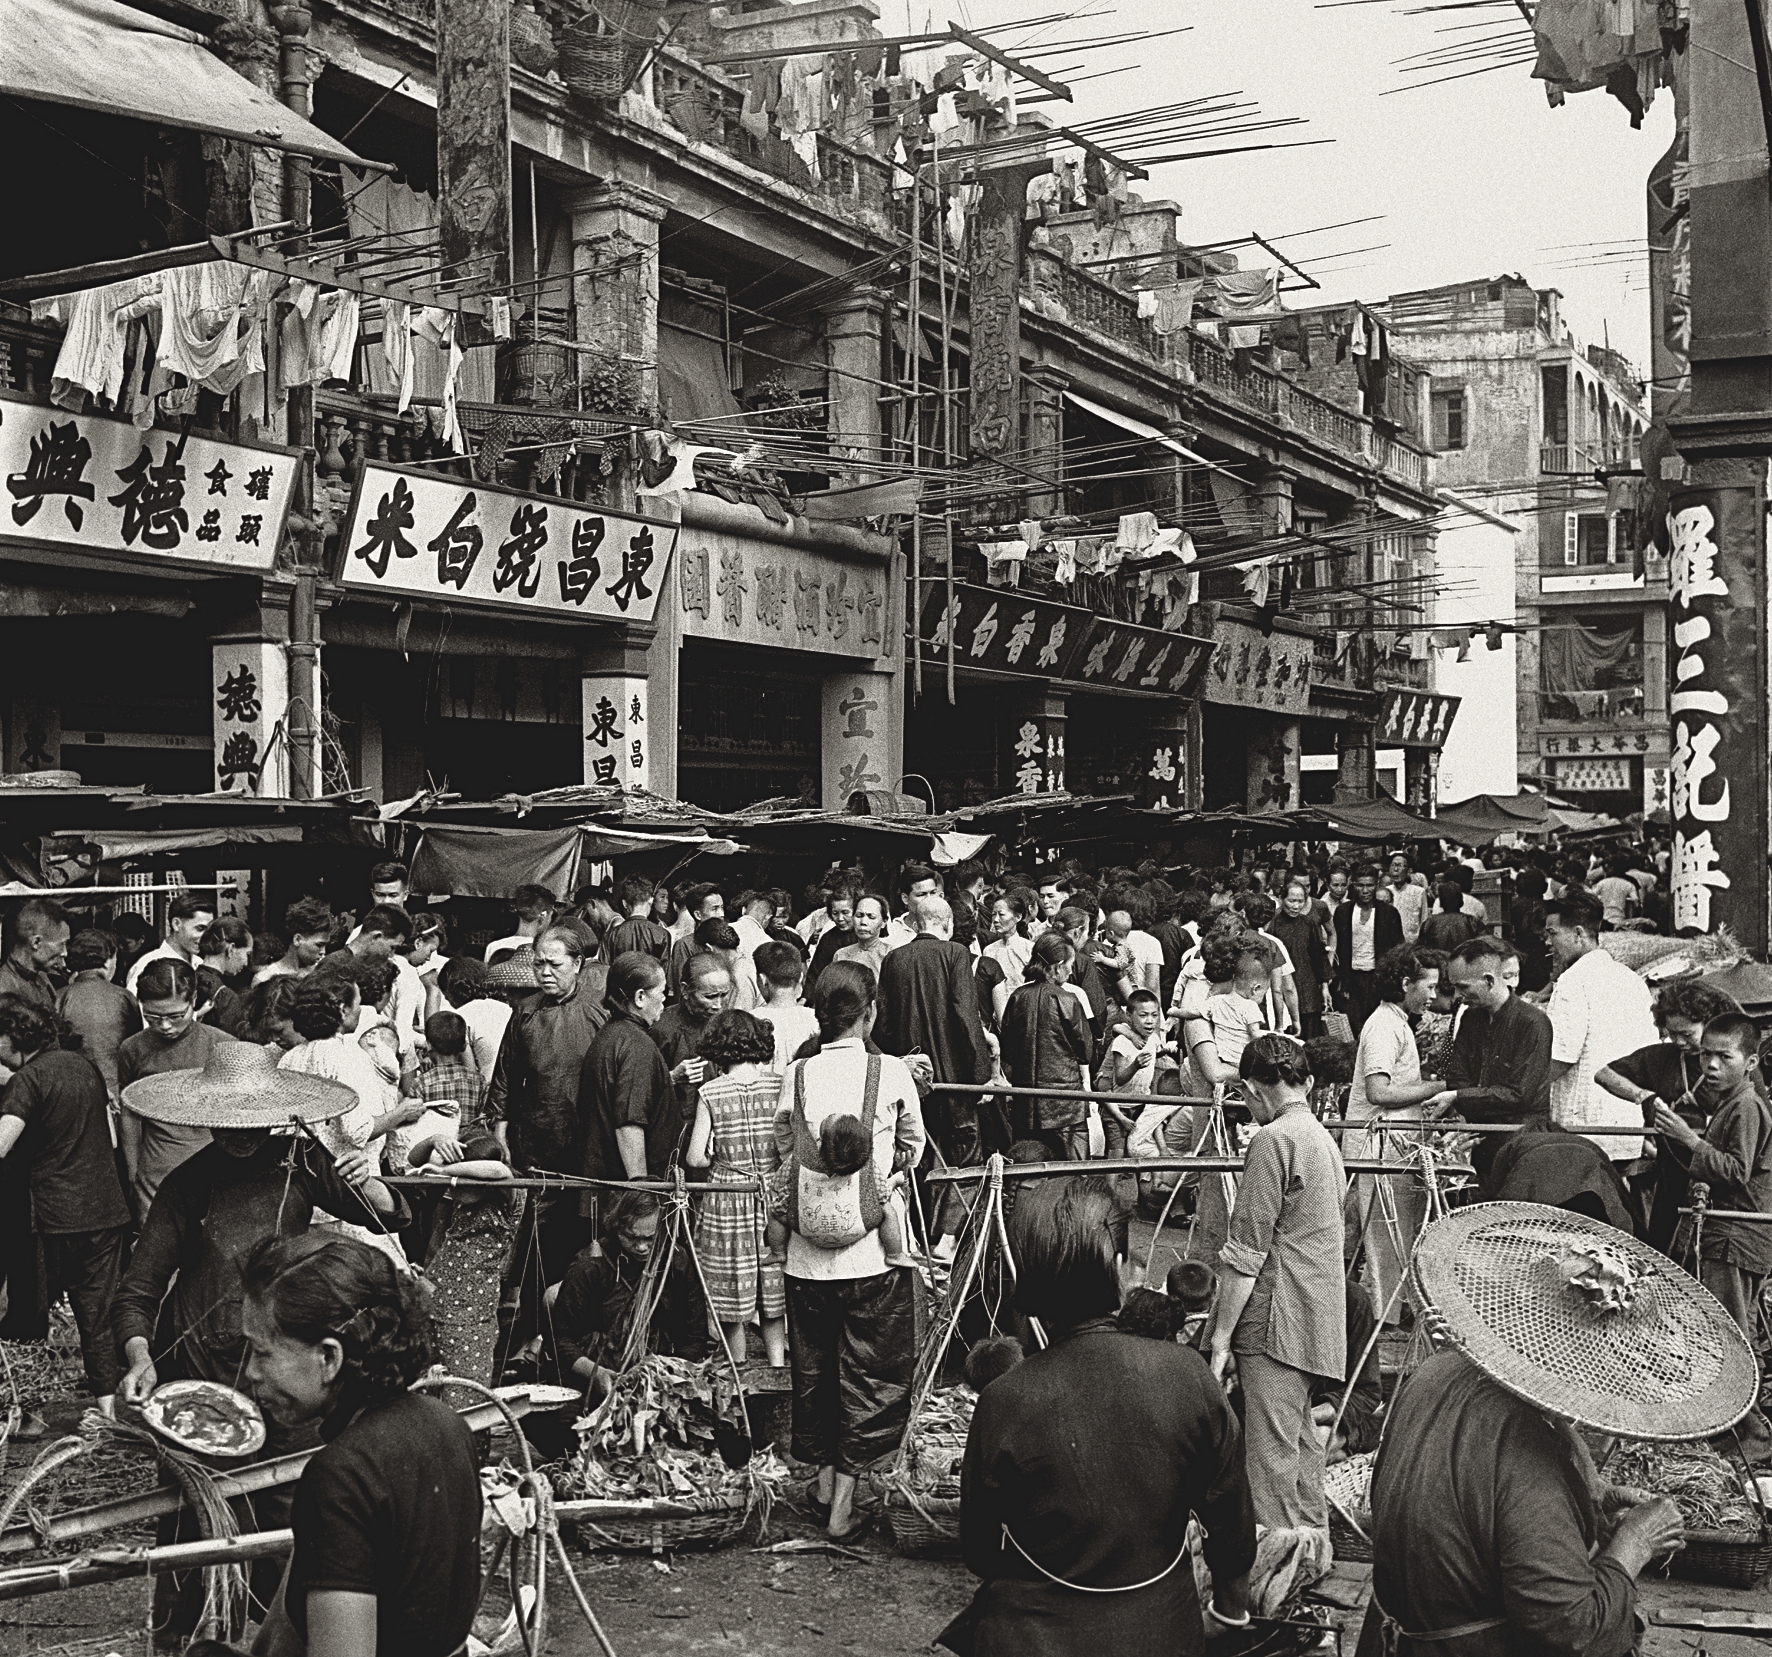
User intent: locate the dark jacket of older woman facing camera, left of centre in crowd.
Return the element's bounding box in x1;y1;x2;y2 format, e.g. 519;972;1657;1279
486;966;608;1173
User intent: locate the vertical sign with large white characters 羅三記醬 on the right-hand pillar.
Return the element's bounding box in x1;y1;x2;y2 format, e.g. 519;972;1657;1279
1667;478;1767;953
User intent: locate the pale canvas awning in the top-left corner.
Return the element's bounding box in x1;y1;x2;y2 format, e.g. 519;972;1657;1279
0;0;377;167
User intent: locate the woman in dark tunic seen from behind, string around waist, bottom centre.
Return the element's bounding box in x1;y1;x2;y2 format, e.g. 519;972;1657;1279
941;1179;1255;1657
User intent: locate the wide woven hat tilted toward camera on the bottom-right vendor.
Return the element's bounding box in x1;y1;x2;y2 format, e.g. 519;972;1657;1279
1409;1203;1760;1441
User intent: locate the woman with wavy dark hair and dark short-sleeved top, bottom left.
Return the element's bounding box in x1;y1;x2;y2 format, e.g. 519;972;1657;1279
241;1232;480;1657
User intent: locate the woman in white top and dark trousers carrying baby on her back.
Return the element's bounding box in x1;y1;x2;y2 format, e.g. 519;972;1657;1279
776;961;925;1538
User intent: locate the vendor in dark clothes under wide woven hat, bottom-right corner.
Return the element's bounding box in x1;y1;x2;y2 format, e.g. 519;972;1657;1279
1357;1203;1758;1657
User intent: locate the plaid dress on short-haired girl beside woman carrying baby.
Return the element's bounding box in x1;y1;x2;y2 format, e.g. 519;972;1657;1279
695;1070;787;1324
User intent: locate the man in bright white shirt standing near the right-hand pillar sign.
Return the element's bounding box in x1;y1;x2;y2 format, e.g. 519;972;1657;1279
1545;891;1659;1163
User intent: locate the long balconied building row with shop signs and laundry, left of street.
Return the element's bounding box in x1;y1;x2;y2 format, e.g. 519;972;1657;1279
0;0;1449;810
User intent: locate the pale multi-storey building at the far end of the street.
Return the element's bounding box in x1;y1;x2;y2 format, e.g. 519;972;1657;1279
1384;276;1667;817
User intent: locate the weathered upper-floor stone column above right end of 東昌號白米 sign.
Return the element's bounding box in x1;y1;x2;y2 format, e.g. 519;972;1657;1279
563;181;670;446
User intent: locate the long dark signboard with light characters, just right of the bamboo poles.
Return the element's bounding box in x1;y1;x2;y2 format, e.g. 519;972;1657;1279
918;581;1212;696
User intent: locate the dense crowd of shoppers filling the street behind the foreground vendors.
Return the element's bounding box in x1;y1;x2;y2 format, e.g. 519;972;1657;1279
0;844;1772;1652
